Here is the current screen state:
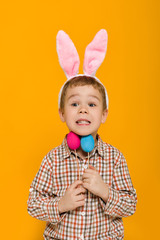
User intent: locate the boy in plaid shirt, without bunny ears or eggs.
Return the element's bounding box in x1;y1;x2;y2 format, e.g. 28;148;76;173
28;30;137;240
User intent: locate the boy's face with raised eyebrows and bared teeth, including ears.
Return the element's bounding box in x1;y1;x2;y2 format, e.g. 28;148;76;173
59;85;108;139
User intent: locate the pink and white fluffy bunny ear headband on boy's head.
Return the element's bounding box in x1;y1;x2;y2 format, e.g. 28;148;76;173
57;29;108;109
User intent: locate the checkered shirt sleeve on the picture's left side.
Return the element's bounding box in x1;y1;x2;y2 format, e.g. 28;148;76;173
27;154;65;224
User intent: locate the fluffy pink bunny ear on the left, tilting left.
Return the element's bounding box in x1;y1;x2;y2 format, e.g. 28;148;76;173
57;30;80;78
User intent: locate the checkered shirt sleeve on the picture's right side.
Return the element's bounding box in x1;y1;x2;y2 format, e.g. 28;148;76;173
101;151;137;218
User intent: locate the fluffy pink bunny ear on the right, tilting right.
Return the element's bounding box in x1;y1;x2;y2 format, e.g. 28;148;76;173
83;29;108;76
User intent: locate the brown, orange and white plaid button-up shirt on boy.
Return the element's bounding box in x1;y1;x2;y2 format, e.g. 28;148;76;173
27;135;137;240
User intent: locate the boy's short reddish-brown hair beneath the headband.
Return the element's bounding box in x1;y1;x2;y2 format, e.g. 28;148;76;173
60;76;107;111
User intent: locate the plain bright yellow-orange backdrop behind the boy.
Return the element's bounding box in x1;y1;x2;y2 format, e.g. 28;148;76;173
0;0;160;240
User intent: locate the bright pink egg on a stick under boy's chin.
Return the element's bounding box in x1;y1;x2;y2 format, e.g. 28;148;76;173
67;132;81;150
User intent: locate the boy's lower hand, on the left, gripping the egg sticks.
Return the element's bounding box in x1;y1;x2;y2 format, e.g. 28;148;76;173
58;180;86;213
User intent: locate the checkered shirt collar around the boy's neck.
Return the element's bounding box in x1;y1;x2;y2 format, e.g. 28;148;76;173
61;134;104;159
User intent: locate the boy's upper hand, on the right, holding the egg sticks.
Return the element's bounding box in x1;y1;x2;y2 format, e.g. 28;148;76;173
82;165;109;202
